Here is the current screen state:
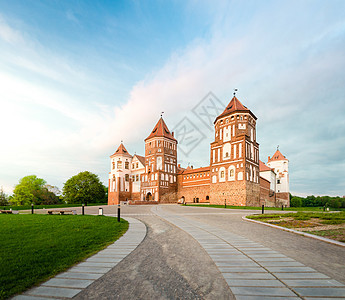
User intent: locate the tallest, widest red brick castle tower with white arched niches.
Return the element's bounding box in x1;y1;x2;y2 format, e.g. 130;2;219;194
210;96;260;206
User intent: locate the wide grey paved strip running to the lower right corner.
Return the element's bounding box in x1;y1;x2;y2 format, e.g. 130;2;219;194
152;206;345;300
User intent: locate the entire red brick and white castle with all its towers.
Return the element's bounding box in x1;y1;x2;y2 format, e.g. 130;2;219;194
108;96;290;206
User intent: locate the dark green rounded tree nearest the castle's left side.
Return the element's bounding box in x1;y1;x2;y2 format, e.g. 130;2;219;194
62;171;106;204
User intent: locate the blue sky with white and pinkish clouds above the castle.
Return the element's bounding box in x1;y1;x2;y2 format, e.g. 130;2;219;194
0;0;345;196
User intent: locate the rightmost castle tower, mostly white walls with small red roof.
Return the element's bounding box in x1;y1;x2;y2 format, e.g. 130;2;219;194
267;149;290;206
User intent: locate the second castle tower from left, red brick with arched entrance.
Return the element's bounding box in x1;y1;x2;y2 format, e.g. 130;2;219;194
141;117;177;202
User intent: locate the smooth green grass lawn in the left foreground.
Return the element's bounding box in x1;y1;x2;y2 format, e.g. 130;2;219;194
0;214;128;299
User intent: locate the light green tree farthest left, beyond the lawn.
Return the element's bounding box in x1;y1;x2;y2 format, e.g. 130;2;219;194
11;175;46;205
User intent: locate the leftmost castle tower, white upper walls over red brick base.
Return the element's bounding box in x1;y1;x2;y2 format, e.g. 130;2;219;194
108;143;132;205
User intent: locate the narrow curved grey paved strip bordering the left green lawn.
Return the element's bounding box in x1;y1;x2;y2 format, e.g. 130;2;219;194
14;217;146;300
